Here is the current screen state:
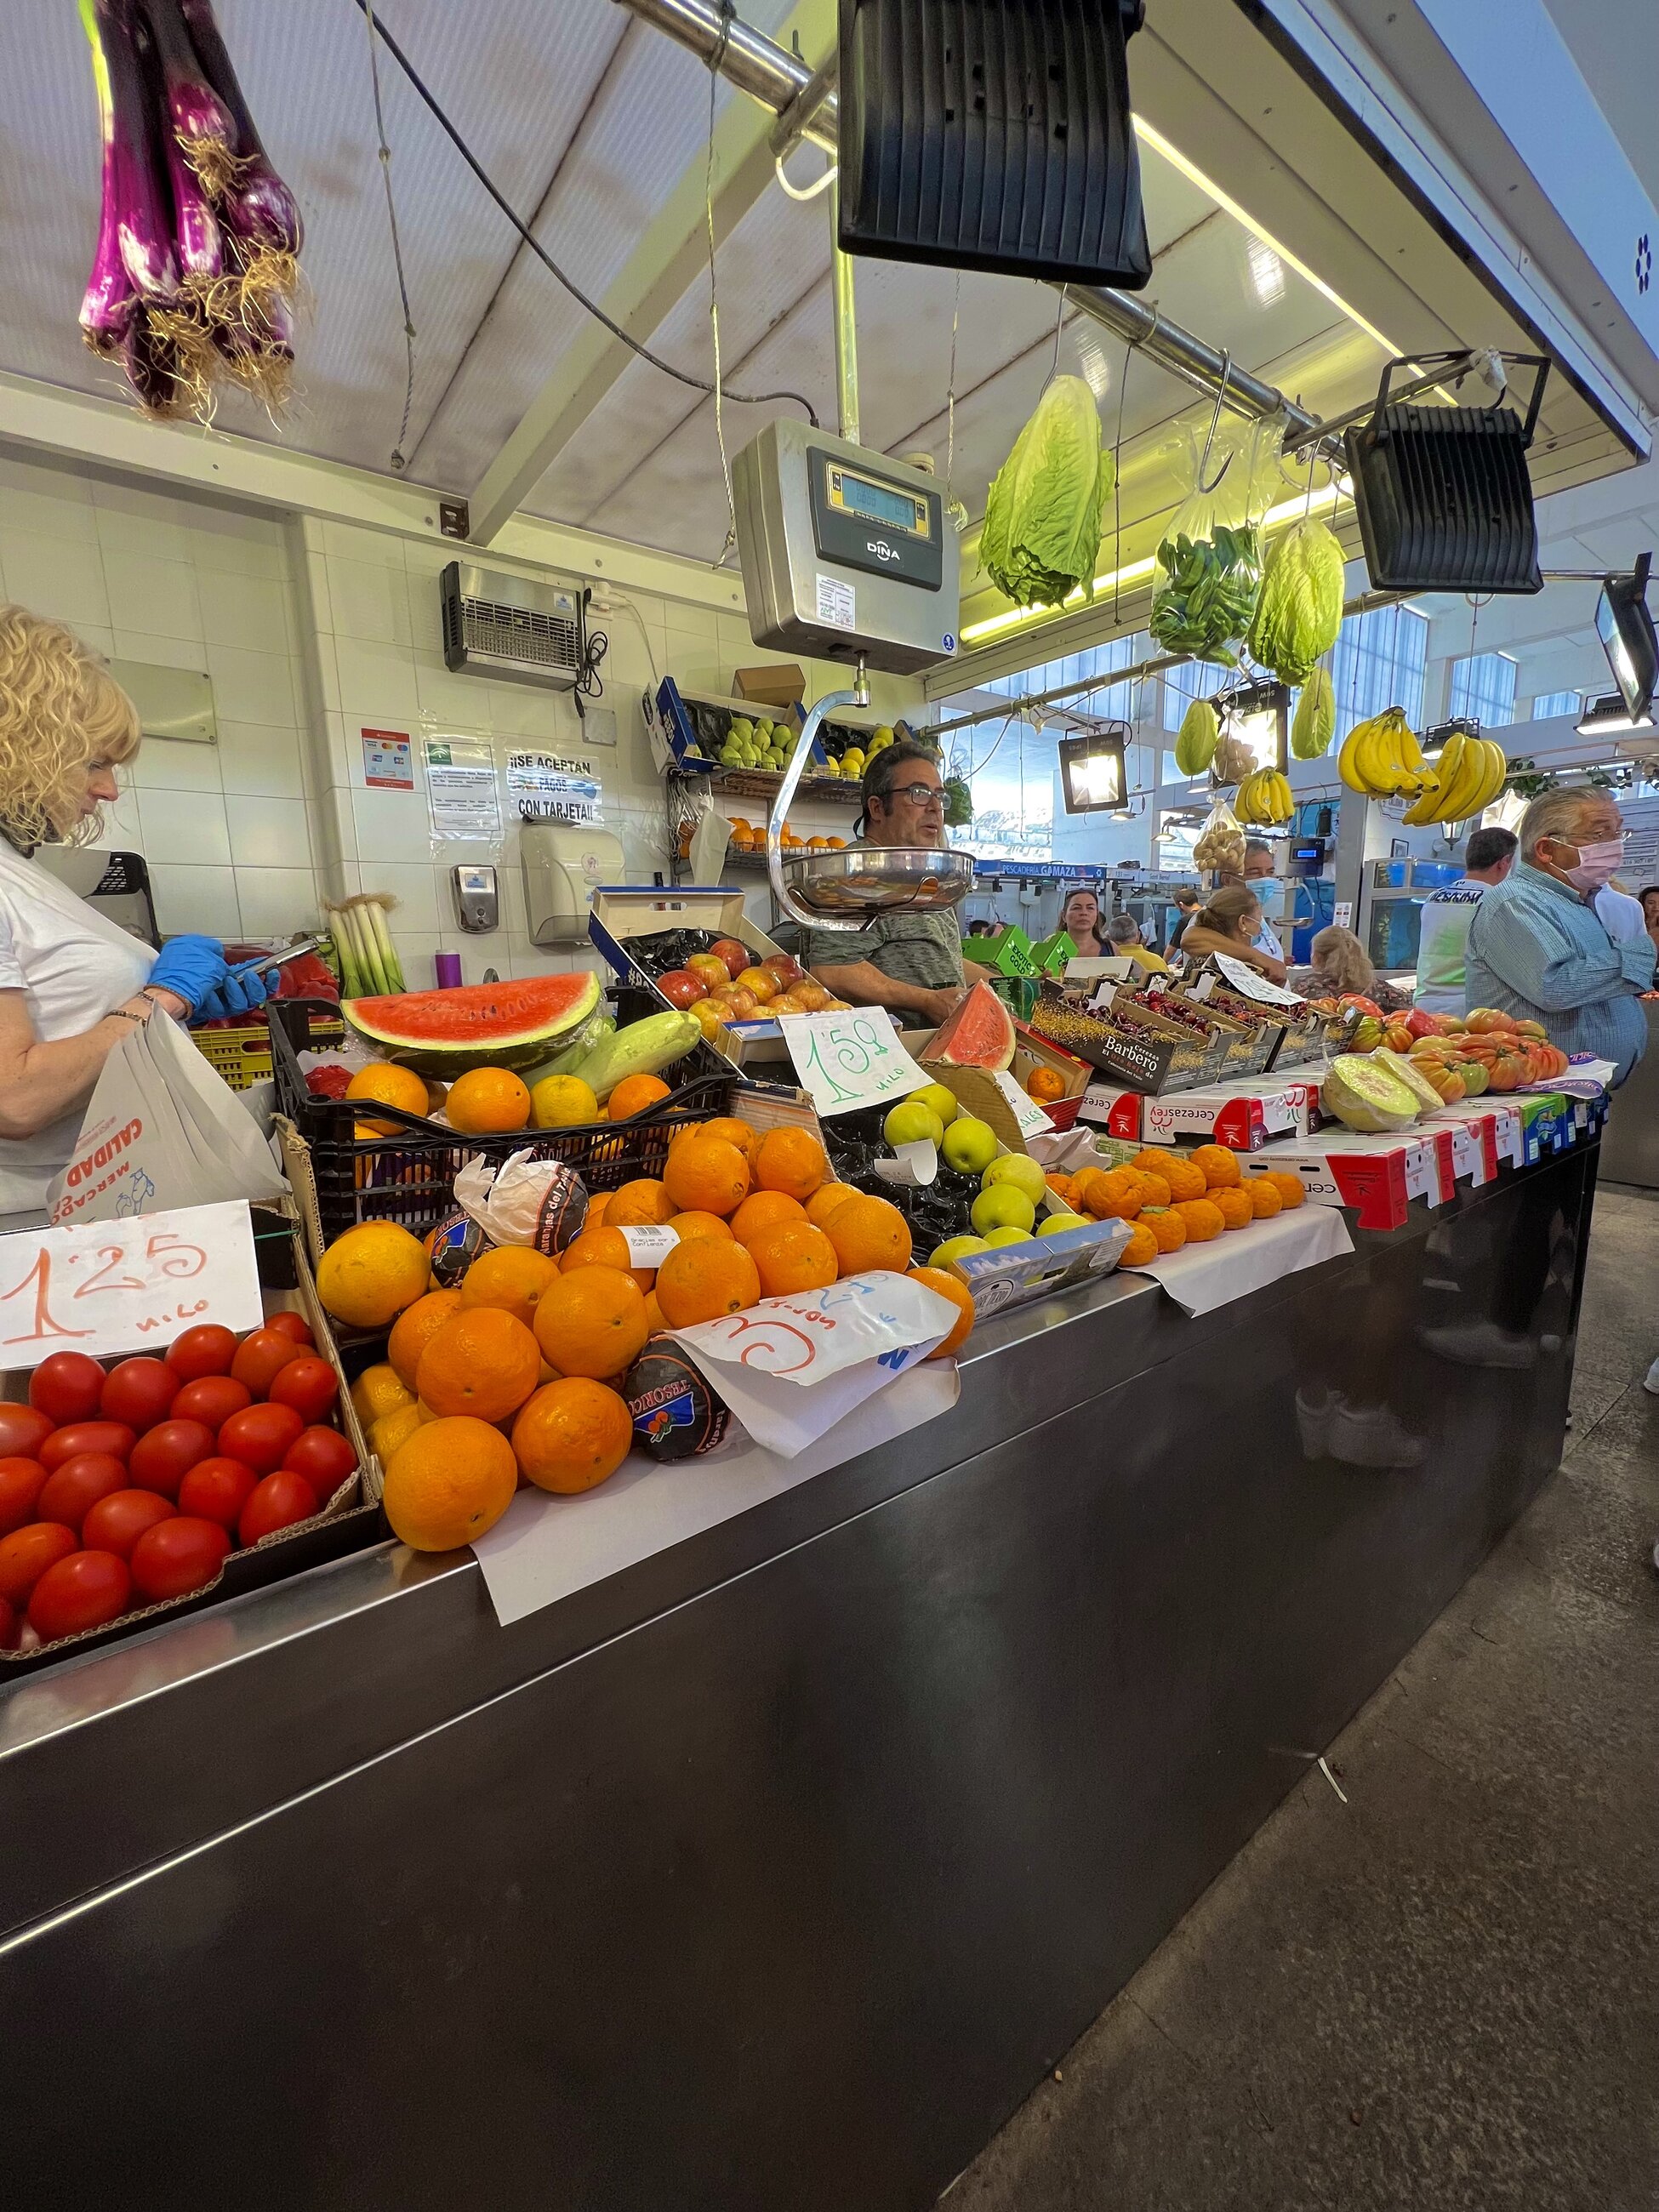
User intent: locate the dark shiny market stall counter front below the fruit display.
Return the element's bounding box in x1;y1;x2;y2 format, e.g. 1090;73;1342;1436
0;1139;1597;2212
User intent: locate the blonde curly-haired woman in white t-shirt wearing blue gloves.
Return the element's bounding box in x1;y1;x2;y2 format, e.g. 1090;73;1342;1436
0;601;265;1232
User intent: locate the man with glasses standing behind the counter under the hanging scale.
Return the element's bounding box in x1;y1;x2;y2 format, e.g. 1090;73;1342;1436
805;744;989;1029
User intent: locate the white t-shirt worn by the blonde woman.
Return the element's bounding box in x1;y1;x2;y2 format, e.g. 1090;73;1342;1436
0;836;155;1214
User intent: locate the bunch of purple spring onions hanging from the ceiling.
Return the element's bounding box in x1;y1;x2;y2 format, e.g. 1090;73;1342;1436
80;0;301;423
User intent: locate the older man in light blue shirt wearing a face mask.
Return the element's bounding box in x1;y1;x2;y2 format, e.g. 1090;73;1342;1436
1464;785;1655;1084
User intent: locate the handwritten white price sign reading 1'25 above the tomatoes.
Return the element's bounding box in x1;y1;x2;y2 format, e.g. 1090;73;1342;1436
0;1201;263;1369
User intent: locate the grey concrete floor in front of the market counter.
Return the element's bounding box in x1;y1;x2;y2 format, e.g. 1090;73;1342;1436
947;1190;1659;2212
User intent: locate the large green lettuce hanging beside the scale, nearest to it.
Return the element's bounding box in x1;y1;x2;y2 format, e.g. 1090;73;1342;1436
980;376;1115;606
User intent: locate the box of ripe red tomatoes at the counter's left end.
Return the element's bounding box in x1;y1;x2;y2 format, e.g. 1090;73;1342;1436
0;1210;385;1688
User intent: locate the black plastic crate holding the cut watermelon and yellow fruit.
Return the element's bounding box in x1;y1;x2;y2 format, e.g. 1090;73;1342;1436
270;984;794;1243
